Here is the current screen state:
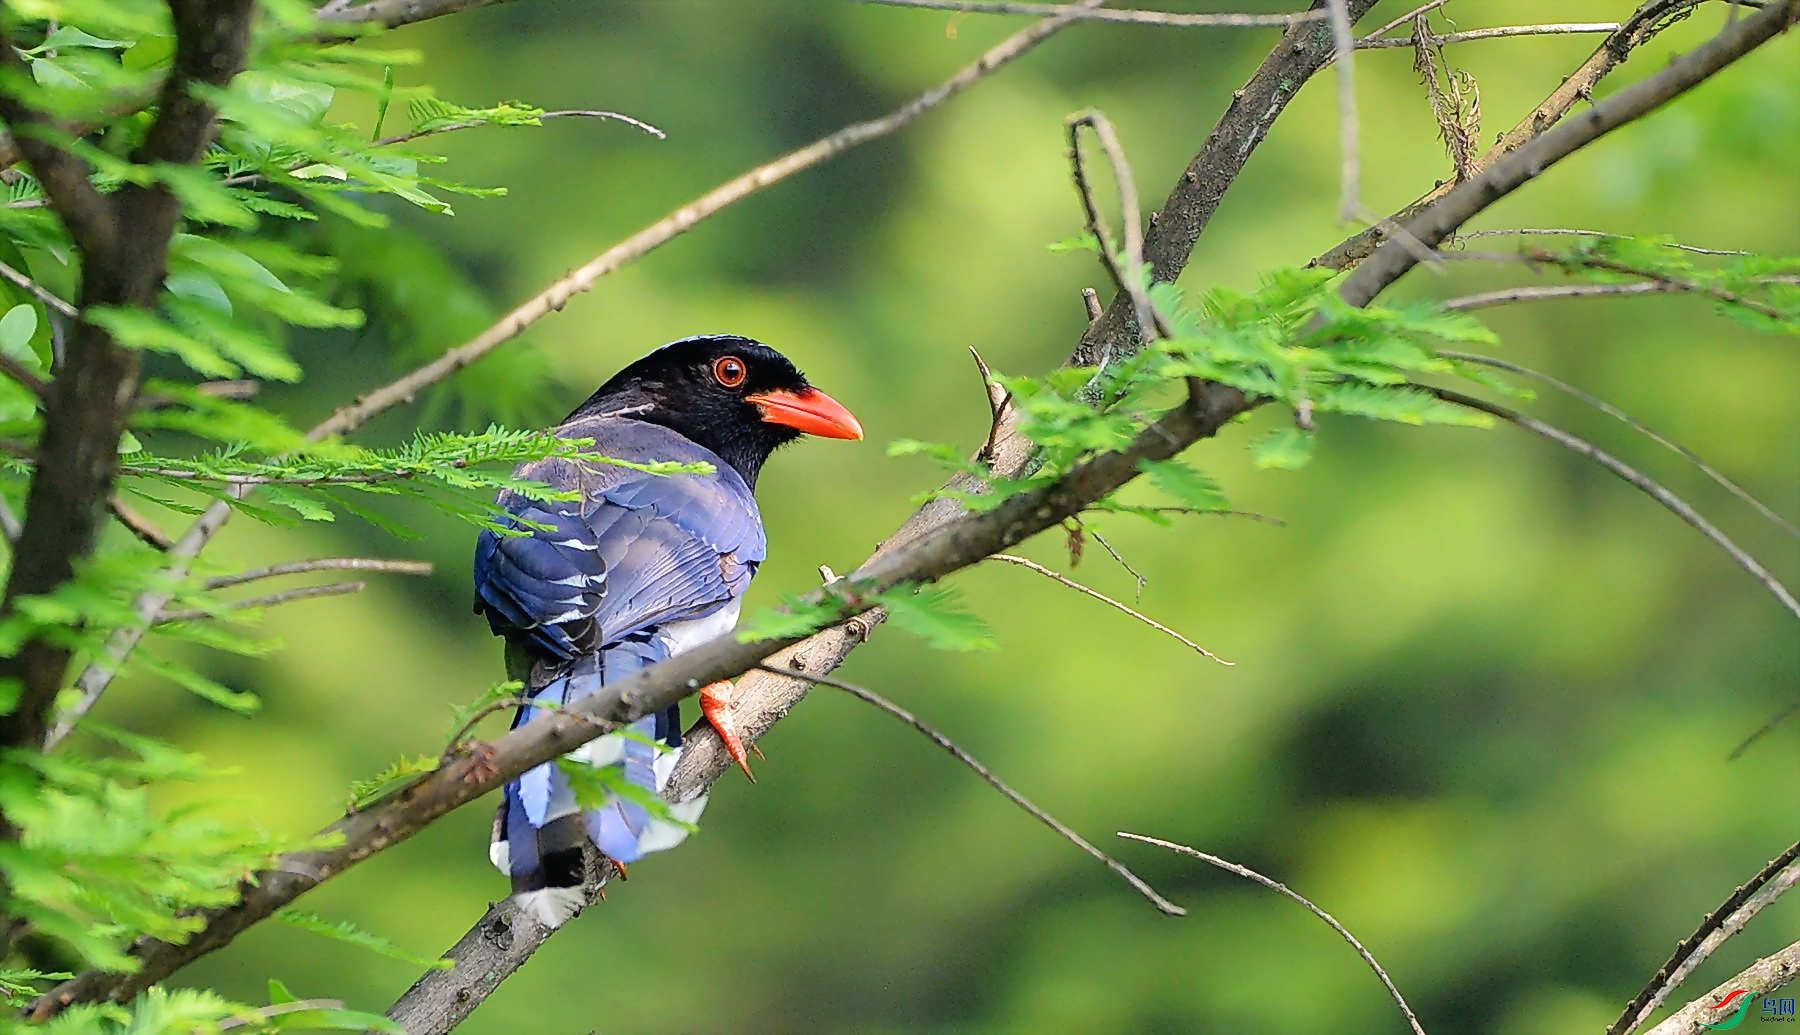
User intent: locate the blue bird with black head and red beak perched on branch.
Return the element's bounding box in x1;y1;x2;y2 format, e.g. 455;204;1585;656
475;335;862;929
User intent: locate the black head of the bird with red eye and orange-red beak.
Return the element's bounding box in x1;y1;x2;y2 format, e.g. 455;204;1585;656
569;335;862;488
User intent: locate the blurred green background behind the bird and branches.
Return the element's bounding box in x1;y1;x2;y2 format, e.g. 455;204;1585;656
103;0;1800;1035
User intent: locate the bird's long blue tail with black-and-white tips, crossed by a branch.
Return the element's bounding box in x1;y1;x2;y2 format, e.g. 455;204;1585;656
490;650;706;927
